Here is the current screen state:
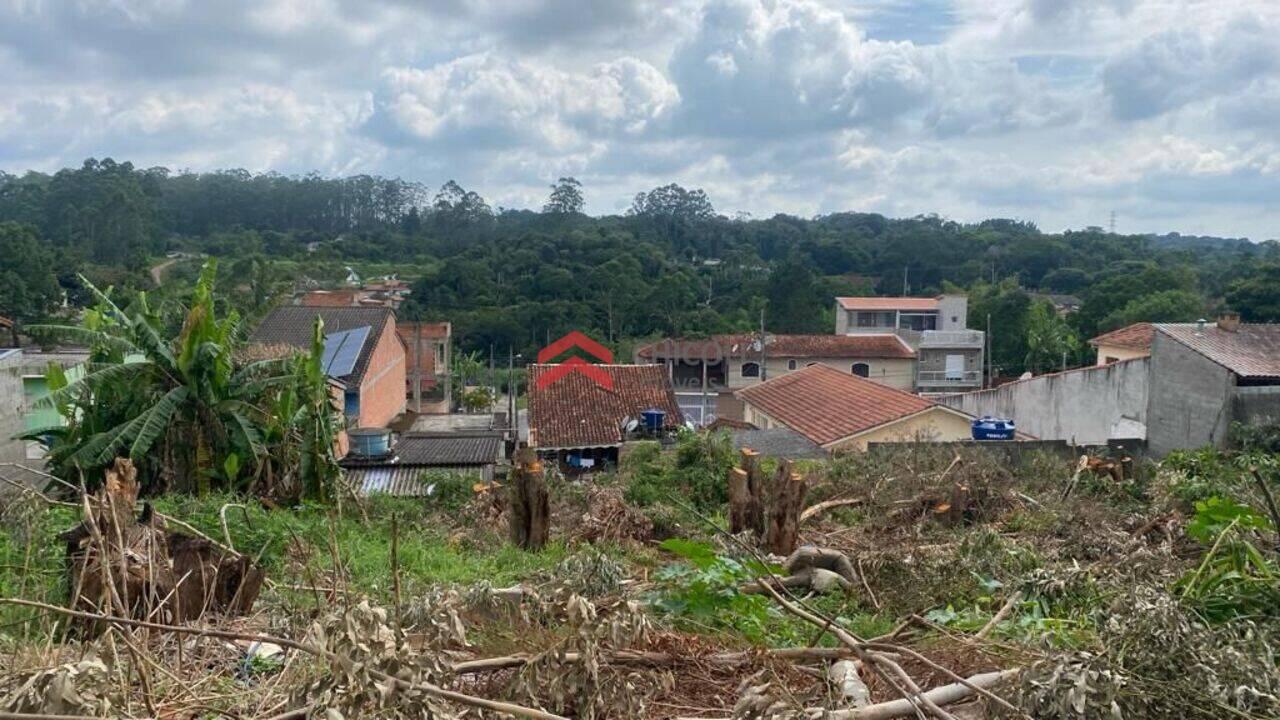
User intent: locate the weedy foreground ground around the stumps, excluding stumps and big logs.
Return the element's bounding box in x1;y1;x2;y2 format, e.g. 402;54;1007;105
0;437;1280;719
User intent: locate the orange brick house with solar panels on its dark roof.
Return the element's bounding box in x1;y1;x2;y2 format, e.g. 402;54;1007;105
250;305;406;428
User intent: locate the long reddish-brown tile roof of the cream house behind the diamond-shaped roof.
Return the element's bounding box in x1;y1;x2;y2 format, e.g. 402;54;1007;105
636;333;915;360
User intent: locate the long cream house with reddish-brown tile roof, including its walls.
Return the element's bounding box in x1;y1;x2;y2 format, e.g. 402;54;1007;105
635;333;915;425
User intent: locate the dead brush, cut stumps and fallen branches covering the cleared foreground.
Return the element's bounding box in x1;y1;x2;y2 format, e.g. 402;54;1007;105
0;440;1280;720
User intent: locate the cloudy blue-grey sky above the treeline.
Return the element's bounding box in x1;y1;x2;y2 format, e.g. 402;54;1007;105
0;0;1280;240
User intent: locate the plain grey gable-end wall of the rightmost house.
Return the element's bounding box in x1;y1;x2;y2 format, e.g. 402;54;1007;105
1146;329;1235;457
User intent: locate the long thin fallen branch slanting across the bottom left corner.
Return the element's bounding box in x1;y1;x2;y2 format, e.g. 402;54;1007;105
0;597;568;720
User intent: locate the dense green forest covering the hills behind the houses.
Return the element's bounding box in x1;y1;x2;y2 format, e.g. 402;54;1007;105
0;159;1280;374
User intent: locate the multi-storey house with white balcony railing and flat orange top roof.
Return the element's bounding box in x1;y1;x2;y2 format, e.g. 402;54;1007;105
836;295;987;393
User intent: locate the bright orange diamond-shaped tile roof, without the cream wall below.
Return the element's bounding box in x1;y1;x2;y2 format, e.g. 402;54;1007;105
735;365;937;445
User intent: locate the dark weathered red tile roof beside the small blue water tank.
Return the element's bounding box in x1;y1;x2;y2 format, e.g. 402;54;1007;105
529;365;684;448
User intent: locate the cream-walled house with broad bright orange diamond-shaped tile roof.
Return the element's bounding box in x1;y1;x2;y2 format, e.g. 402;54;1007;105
736;365;973;451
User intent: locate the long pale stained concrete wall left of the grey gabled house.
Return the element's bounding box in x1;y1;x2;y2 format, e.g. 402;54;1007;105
938;359;1151;445
